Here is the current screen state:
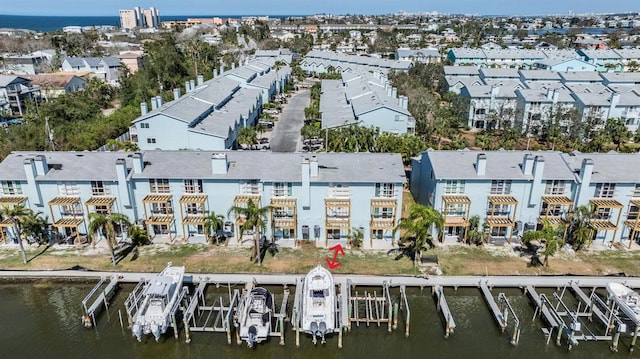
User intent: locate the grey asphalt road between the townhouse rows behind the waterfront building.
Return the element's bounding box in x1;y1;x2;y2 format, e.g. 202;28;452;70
271;90;309;152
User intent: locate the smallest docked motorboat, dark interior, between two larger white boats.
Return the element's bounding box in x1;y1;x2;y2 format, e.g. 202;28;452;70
238;287;274;348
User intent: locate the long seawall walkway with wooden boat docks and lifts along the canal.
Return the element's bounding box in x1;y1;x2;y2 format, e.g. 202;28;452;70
5;271;640;350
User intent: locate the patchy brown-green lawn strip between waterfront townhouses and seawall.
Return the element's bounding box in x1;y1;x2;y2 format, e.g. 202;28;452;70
0;242;640;276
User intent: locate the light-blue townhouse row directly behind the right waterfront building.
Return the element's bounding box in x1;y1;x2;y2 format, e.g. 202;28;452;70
444;66;640;135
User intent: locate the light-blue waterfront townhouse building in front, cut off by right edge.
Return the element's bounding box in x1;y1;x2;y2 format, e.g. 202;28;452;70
410;150;640;245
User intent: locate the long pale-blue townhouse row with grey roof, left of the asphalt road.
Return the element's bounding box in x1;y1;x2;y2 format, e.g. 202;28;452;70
130;58;291;150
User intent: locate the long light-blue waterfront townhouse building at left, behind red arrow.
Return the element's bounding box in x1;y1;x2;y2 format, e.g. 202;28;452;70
0;150;405;249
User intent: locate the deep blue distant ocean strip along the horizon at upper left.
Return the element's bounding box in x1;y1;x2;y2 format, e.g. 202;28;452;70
0;15;297;32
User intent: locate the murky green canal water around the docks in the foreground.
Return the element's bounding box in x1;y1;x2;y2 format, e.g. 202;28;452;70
0;282;640;359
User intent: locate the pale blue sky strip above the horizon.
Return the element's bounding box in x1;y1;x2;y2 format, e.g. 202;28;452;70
0;0;640;16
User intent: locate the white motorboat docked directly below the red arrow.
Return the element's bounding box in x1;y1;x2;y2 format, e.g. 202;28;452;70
300;265;336;344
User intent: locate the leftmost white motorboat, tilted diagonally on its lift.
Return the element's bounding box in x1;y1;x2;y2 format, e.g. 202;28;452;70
131;263;184;341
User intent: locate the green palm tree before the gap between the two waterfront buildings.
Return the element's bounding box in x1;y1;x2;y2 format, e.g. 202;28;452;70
393;203;444;265
